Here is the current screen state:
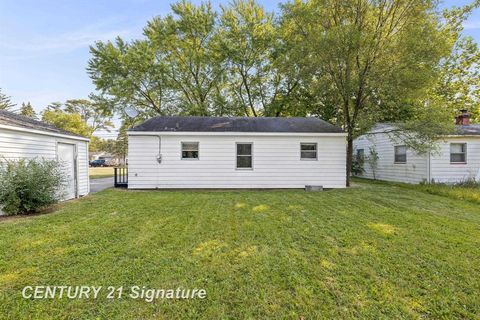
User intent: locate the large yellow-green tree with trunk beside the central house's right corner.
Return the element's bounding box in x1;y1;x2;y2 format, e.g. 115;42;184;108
282;0;456;185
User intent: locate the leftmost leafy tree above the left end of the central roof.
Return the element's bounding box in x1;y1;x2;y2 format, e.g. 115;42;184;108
87;37;172;115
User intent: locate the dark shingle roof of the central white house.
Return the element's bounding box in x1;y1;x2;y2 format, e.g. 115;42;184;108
129;116;343;133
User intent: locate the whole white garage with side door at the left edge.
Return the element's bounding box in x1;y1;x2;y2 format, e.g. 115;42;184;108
0;110;90;199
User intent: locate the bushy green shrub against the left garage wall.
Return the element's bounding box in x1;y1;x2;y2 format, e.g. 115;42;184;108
0;159;66;215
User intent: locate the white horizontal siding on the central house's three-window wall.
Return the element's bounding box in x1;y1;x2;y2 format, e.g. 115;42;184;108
128;135;346;189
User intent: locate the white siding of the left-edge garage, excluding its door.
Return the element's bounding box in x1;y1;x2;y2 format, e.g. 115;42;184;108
0;128;90;196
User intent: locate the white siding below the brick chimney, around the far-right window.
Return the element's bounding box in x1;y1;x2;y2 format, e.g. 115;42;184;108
431;136;480;183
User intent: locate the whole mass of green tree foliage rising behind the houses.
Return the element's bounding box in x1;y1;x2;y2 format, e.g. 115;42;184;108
84;0;479;185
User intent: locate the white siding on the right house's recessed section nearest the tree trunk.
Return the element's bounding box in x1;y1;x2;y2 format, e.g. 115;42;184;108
354;132;428;183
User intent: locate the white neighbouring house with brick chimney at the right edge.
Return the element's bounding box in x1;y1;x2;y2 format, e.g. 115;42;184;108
354;110;480;183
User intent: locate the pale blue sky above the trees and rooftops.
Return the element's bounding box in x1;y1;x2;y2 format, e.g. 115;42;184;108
0;0;480;139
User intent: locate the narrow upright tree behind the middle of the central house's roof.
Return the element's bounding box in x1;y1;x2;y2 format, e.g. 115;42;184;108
218;0;282;116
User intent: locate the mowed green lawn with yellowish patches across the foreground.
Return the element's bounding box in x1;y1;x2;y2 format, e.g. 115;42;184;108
0;182;480;319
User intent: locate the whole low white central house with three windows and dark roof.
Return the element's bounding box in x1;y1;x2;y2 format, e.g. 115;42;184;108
128;117;346;189
